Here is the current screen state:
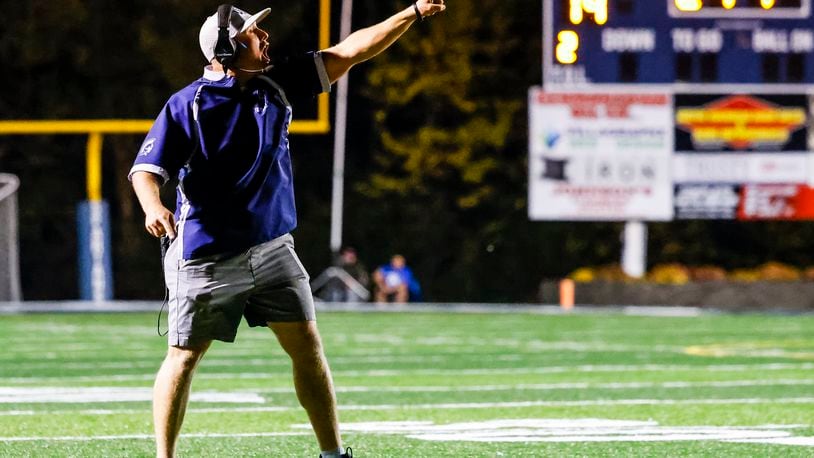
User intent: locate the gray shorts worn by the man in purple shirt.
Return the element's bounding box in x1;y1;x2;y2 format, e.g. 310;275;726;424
164;234;316;347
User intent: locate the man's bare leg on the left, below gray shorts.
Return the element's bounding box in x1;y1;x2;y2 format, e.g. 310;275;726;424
153;341;211;458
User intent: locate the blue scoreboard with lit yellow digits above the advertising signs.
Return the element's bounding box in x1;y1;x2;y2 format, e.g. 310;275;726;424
543;0;814;93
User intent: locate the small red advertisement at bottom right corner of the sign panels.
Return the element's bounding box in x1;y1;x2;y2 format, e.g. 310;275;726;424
738;184;814;221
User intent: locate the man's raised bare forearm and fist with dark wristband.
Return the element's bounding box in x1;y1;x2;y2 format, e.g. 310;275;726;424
322;0;447;83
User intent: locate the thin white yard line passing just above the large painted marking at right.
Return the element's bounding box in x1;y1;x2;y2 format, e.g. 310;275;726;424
0;397;814;416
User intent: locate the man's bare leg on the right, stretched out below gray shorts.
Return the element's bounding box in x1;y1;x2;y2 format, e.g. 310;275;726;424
269;321;342;450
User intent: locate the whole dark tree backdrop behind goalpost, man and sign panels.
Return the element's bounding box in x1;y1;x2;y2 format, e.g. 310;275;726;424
0;0;814;301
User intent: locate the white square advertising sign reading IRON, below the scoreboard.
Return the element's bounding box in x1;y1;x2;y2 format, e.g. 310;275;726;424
529;88;674;221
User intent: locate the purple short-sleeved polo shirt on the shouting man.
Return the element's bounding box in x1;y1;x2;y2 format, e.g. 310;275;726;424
129;52;330;259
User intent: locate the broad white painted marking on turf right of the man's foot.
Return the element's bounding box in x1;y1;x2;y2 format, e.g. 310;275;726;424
314;418;814;447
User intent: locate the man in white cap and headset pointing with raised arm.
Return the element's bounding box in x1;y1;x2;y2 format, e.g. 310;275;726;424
130;0;445;458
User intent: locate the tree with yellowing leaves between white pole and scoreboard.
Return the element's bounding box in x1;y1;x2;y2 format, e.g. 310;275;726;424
350;0;568;300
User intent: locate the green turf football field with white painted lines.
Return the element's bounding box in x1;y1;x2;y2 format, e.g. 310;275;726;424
0;312;814;457
